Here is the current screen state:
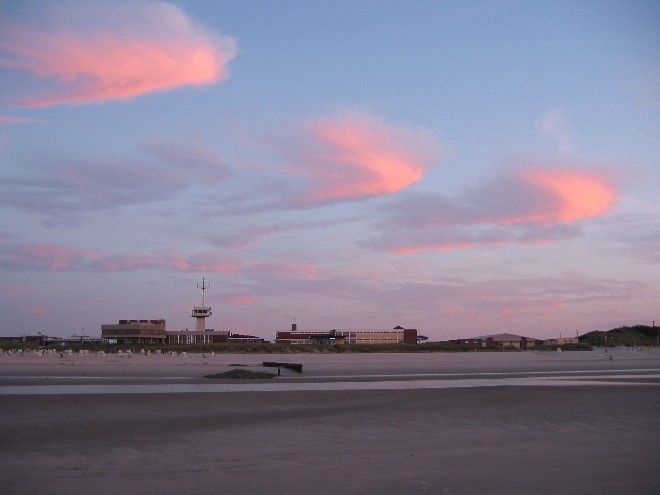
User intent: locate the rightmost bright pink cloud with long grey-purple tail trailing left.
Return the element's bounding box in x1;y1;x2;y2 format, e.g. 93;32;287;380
371;165;618;254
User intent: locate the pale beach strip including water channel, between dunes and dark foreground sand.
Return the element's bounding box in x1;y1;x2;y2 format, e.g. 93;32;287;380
0;350;660;394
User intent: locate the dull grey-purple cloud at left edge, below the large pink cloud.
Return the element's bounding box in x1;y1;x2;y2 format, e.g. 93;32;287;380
0;140;229;218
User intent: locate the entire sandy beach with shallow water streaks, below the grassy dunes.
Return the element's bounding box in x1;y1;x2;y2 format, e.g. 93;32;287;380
0;350;660;494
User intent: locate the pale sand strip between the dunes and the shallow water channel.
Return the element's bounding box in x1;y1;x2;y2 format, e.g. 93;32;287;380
0;349;660;385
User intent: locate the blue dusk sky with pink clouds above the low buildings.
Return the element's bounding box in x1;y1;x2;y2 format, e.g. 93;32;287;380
0;0;660;340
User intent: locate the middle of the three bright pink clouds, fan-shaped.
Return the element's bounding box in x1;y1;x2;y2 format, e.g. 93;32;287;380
293;113;439;204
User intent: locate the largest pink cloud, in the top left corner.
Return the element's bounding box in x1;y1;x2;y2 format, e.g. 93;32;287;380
0;2;236;106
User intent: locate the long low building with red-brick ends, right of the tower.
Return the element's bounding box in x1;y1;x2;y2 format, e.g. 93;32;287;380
276;323;417;344
